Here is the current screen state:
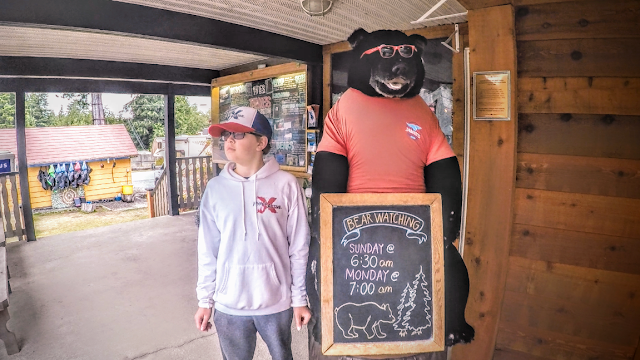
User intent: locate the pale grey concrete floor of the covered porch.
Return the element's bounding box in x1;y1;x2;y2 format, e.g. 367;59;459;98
0;213;308;360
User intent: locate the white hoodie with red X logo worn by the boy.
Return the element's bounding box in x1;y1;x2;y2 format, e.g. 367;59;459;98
196;159;309;316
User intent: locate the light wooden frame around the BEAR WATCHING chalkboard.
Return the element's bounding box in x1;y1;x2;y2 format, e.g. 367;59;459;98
320;194;445;356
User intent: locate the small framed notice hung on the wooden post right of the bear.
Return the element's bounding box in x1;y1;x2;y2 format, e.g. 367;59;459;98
473;71;511;120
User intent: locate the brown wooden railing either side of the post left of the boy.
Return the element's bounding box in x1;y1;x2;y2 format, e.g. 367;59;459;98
147;156;216;217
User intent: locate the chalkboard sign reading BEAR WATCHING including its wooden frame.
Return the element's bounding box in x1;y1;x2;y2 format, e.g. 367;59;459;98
320;194;444;355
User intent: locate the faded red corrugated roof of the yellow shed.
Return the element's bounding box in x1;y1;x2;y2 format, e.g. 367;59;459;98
0;125;138;166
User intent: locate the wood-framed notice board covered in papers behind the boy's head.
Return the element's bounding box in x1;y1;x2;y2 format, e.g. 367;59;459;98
218;72;307;171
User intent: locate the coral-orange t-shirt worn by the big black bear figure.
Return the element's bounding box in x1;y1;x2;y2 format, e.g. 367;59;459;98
318;89;455;193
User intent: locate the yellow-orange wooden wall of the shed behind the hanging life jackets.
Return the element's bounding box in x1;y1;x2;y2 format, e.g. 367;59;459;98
29;159;131;209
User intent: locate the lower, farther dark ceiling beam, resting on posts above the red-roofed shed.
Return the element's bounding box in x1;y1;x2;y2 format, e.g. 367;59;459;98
0;56;220;84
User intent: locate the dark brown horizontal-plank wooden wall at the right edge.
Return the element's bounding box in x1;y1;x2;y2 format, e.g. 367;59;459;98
493;0;640;360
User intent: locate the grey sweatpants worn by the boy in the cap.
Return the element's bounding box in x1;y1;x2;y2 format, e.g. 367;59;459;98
213;309;293;360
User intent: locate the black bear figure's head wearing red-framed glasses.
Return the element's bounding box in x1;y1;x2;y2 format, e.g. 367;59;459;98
347;29;427;98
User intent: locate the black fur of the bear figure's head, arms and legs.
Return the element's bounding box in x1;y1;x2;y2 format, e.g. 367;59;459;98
307;29;474;360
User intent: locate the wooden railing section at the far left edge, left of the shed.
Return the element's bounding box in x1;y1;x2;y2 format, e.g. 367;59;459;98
0;172;27;240
